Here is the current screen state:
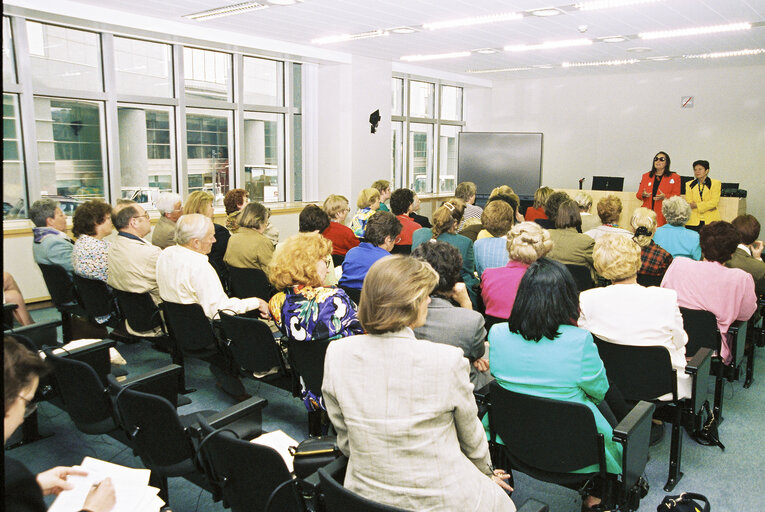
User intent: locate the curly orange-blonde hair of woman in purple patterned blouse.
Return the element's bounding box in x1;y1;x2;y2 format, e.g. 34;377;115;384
268;233;332;290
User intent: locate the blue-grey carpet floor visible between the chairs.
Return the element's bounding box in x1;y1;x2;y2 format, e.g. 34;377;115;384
7;309;765;512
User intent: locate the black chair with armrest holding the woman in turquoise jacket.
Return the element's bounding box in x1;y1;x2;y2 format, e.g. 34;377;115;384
489;381;655;510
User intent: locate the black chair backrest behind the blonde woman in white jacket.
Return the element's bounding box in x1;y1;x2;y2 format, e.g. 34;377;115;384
592;335;677;401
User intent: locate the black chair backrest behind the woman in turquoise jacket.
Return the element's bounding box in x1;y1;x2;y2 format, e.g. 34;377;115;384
489;381;605;477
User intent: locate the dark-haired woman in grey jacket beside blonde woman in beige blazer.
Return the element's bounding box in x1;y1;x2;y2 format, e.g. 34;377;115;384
412;242;491;389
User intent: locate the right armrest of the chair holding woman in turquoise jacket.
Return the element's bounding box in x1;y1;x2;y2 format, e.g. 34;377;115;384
613;400;656;489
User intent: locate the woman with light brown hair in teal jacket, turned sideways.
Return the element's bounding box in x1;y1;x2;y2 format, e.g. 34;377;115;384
412;197;479;305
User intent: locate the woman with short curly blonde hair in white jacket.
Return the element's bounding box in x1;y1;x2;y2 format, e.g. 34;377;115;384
577;236;692;400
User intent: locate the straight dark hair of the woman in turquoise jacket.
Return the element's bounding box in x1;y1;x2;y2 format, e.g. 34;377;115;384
509;258;579;341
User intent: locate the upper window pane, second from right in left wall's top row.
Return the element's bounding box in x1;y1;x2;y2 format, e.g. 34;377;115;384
183;48;231;101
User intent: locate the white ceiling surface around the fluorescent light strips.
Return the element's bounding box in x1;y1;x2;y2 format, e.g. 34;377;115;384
49;0;765;80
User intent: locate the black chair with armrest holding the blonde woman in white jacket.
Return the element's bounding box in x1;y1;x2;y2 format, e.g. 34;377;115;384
593;335;712;492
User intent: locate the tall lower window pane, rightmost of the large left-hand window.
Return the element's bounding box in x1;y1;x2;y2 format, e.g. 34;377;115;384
243;112;284;203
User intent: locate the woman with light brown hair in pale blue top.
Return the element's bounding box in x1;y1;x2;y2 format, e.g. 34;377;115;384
473;201;515;276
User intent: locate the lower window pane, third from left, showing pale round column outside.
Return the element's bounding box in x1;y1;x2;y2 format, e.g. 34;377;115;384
117;105;175;202
